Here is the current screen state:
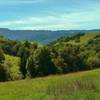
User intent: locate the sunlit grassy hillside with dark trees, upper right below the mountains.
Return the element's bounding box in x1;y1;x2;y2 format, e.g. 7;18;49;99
54;32;100;45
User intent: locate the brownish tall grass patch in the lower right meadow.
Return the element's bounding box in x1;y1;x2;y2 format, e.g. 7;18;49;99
47;80;99;100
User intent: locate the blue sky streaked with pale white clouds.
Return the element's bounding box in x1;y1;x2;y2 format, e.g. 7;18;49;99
0;0;100;30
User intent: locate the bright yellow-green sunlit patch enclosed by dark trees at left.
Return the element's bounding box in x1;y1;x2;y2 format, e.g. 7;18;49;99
4;55;22;80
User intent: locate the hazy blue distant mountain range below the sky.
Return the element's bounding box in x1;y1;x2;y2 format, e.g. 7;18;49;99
0;28;100;44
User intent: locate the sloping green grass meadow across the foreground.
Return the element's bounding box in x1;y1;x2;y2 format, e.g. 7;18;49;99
0;69;100;100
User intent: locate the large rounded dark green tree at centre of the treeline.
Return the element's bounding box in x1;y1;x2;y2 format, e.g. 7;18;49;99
27;47;56;77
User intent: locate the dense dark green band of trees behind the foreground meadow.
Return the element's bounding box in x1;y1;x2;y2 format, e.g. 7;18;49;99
0;34;100;81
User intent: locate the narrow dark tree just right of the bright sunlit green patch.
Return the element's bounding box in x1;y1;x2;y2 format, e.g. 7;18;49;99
18;41;38;78
